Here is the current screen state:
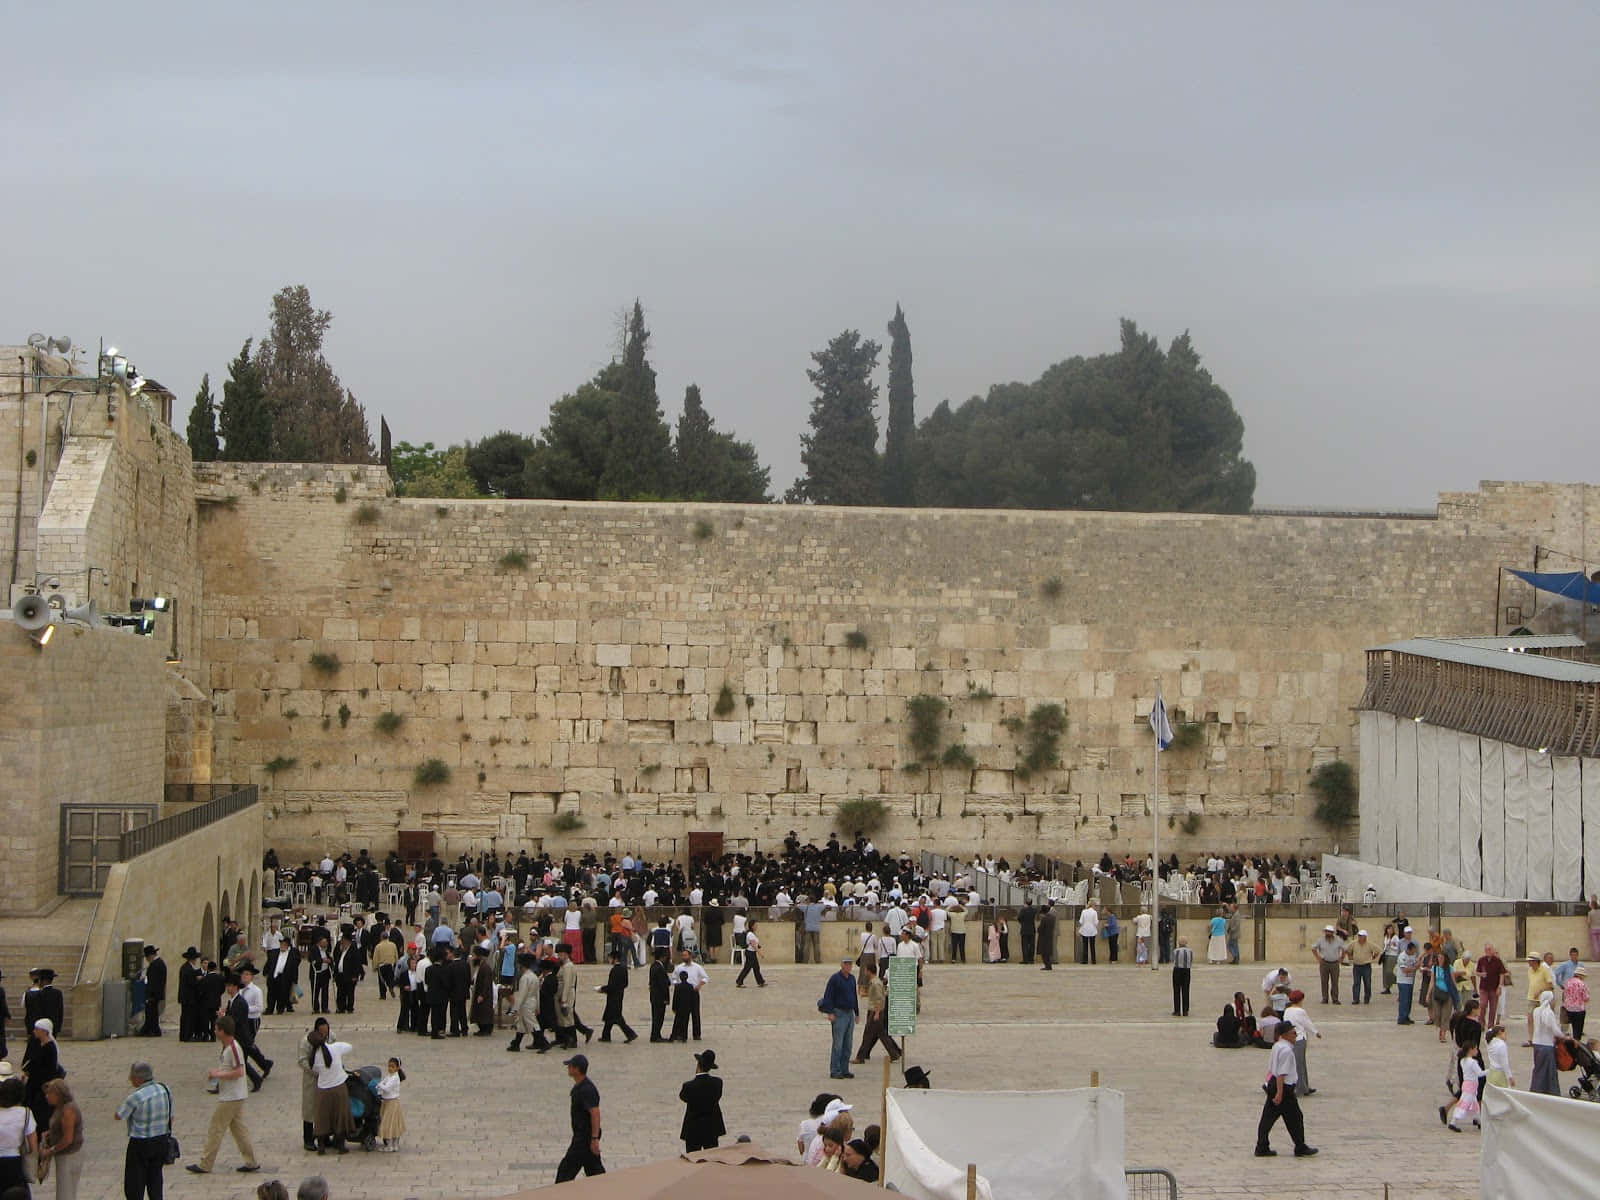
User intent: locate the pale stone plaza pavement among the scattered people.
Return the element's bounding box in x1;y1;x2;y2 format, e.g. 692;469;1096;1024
50;962;1497;1200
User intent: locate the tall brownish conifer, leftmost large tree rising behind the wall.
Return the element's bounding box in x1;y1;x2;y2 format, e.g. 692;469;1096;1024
256;285;373;462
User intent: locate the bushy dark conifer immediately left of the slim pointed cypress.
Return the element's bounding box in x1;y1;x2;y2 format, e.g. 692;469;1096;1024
786;330;880;504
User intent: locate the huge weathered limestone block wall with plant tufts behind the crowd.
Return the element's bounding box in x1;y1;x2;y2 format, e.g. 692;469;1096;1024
190;466;1530;856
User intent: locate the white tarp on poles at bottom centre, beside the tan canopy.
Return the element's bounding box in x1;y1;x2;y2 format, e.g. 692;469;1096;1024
883;1088;1128;1200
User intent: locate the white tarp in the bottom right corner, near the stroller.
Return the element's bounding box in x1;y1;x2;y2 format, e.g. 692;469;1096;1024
1478;1088;1600;1197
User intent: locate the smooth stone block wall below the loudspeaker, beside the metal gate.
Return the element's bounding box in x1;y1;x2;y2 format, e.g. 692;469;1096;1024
0;621;166;915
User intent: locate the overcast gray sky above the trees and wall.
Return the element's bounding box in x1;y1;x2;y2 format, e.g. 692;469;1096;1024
0;0;1600;506
